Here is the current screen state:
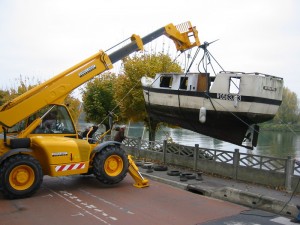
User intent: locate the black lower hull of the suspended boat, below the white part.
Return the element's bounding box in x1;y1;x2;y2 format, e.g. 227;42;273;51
146;104;273;147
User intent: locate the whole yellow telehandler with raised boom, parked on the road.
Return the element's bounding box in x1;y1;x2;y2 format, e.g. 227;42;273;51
0;22;200;199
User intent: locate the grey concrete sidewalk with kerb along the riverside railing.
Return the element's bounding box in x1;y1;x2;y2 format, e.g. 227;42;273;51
138;164;300;217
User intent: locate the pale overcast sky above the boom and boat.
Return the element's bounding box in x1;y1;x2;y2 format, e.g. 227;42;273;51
0;0;300;97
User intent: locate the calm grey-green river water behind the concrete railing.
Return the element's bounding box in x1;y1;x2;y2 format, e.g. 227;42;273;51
126;124;300;158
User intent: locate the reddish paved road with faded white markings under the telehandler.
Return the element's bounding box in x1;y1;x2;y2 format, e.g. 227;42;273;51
0;176;296;225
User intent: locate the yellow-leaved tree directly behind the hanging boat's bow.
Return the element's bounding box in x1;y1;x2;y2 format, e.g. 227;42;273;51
114;53;181;140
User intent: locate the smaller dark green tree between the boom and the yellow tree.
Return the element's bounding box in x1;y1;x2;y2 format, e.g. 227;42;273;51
82;72;116;129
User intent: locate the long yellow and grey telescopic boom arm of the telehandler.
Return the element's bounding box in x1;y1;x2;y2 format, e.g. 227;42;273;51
0;22;200;130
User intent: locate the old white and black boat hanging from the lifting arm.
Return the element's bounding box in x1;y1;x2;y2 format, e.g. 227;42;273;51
142;72;283;149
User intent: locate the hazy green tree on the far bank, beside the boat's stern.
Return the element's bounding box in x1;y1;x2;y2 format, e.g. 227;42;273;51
274;87;299;124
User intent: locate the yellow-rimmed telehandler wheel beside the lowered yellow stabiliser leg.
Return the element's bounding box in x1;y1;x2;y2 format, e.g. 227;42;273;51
93;145;129;184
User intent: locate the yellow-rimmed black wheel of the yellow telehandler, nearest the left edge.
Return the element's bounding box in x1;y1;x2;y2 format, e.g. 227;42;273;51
0;154;43;199
